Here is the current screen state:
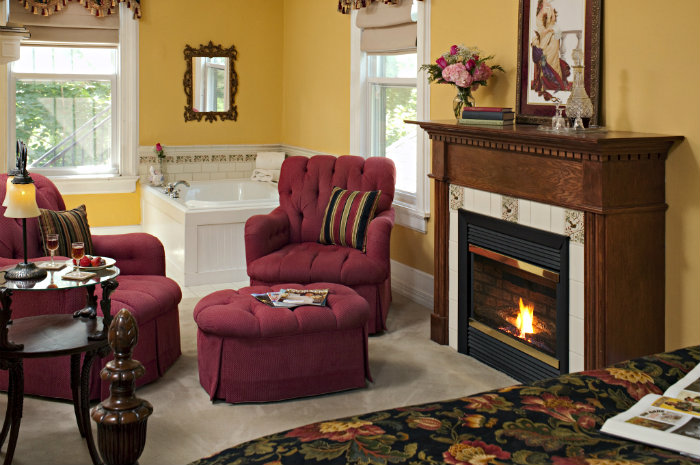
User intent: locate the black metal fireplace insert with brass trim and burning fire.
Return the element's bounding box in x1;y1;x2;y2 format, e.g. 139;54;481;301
458;210;569;382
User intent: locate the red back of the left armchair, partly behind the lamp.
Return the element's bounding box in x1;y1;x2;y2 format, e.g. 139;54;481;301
0;173;66;258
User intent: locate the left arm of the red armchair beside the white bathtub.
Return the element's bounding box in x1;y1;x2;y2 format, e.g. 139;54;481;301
245;207;289;265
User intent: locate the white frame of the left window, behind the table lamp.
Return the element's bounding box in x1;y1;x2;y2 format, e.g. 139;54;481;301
5;3;139;194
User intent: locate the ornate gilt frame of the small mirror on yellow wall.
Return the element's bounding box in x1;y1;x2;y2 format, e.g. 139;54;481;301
182;41;238;123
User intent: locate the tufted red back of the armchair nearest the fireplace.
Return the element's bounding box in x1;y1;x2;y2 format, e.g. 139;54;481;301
278;155;396;243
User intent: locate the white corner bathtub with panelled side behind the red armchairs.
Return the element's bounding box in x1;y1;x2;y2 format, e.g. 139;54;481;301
141;179;279;286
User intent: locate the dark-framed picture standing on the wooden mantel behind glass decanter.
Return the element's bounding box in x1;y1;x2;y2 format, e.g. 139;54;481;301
516;0;602;124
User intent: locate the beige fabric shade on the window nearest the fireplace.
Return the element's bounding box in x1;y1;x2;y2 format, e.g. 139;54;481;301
355;0;418;54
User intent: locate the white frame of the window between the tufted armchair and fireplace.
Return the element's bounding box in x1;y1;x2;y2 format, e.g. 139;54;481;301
350;2;430;233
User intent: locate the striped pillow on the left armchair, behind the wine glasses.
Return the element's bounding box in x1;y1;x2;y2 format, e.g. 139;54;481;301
39;205;94;257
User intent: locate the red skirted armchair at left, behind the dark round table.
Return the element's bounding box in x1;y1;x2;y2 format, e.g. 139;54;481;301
0;173;182;399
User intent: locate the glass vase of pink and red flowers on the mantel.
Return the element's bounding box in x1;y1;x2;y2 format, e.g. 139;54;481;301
420;45;503;120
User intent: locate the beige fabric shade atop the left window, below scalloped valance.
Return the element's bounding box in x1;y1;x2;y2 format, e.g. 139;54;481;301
10;1;119;46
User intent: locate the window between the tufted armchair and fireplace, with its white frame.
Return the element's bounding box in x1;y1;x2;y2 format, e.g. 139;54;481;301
350;2;430;232
